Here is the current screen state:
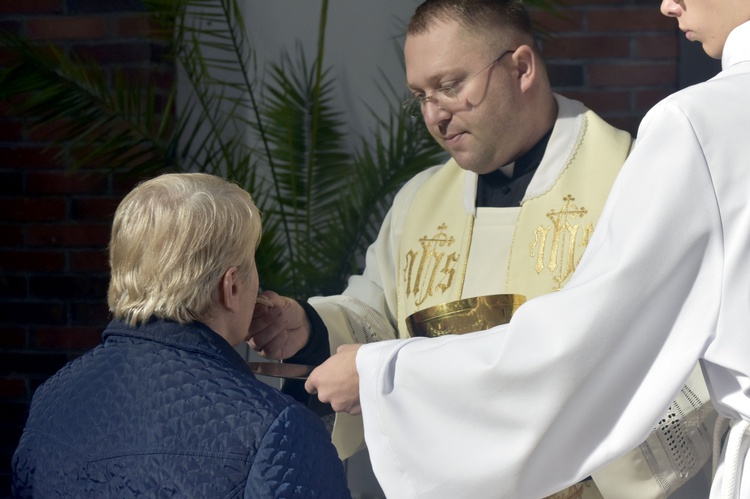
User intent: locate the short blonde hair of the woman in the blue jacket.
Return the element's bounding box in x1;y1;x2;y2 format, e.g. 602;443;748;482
107;173;261;326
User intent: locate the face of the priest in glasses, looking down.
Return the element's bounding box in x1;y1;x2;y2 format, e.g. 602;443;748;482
404;22;530;174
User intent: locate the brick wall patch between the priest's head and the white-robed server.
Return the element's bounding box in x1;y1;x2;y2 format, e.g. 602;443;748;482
535;0;679;134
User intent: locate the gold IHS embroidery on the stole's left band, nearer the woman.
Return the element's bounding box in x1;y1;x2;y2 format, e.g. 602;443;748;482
404;223;459;306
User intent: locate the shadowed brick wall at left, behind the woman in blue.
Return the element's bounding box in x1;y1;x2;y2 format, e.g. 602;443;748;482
0;0;172;496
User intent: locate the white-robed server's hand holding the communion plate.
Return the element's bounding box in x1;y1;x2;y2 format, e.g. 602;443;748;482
305;345;362;416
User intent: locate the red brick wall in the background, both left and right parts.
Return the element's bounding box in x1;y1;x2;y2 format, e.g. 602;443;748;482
0;0;678;496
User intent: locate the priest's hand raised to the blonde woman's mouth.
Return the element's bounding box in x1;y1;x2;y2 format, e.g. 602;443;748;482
247;291;312;359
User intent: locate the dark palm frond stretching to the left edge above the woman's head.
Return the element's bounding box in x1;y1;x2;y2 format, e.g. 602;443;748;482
0;33;174;172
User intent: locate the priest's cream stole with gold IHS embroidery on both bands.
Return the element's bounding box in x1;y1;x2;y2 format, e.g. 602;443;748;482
398;111;631;337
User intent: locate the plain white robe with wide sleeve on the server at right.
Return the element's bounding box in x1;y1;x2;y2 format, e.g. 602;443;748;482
357;23;750;499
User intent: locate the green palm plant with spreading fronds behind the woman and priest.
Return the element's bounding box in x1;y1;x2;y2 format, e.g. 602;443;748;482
0;0;442;298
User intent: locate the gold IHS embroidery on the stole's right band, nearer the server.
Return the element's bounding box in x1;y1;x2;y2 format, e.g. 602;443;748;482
529;194;594;291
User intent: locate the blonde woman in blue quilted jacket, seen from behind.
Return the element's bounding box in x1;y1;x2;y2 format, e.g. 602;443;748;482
13;174;350;498
